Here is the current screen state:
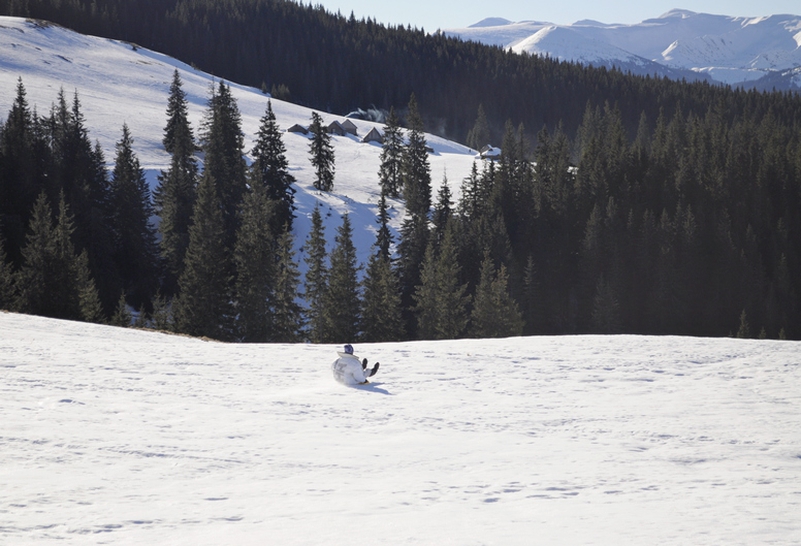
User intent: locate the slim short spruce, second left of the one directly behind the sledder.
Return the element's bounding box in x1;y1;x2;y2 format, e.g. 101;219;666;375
272;229;304;343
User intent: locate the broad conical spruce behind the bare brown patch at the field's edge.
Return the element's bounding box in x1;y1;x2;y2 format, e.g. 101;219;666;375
173;171;233;340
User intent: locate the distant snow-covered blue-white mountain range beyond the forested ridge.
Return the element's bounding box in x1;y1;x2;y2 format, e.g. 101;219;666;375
445;9;801;89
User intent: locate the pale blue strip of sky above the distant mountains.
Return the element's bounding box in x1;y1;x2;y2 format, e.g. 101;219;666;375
310;0;801;32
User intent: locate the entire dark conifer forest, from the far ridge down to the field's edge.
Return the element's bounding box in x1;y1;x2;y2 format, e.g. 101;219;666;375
0;0;801;342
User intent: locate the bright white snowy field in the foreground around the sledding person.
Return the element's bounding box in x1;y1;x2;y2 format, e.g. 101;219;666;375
0;313;801;545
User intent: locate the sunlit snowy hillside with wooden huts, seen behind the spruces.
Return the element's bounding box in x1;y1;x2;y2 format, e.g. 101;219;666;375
0;17;475;268
